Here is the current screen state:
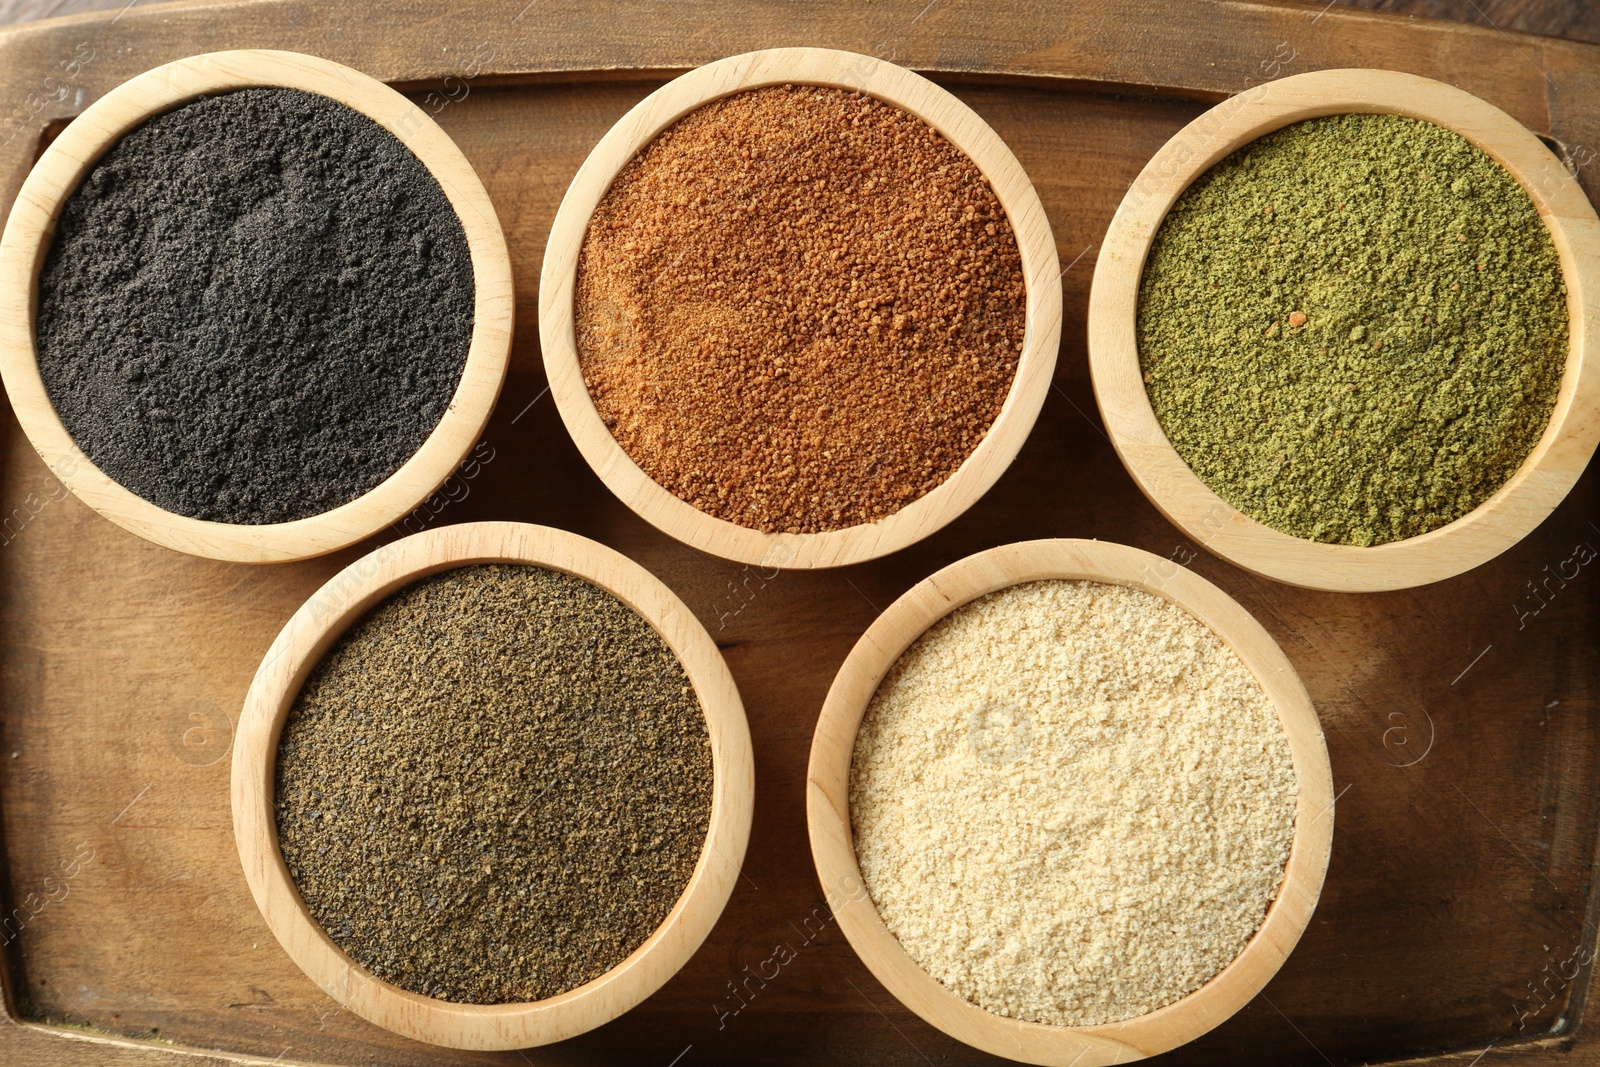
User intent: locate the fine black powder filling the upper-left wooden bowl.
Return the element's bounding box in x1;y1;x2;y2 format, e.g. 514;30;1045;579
35;90;474;525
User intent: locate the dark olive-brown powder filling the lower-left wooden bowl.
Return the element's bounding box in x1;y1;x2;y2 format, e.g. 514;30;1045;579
277;565;712;1005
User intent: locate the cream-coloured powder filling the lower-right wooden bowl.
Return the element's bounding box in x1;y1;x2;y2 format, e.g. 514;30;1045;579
850;581;1296;1025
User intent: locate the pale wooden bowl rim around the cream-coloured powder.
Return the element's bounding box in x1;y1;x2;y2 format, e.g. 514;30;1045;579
806;539;1334;1067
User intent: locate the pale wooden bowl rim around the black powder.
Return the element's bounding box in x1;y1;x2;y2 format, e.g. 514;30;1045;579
0;51;512;563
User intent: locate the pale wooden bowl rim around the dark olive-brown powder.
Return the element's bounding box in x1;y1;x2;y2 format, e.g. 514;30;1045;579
232;522;755;1049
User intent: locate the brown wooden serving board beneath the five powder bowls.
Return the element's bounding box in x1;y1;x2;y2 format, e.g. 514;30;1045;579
0;0;1600;1067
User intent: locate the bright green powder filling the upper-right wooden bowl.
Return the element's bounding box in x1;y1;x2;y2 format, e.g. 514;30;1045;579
1138;115;1566;545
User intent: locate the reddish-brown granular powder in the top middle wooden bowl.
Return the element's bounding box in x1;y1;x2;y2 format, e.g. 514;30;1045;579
576;85;1027;533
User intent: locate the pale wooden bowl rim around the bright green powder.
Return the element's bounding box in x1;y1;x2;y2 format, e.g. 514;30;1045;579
1090;70;1600;592
